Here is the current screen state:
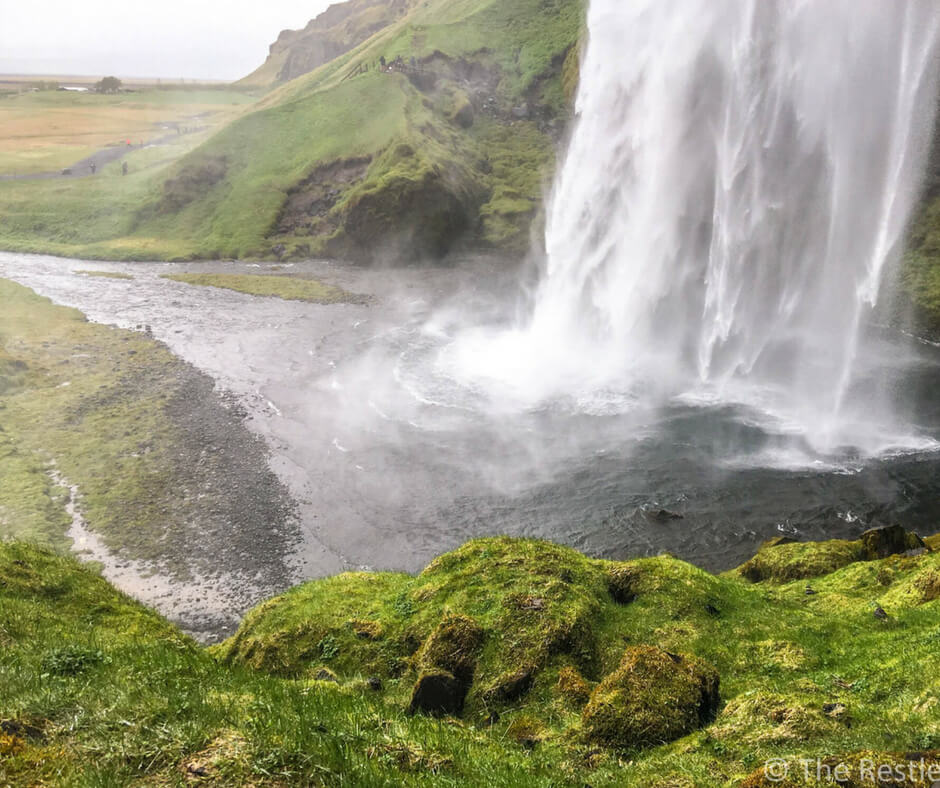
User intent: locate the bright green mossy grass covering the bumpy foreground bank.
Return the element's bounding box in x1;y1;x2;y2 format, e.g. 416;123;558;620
0;538;940;788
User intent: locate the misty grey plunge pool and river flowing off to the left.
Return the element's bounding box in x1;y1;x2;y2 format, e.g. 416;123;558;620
0;253;940;624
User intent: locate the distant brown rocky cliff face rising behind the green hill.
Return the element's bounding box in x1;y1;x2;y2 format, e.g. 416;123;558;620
241;0;415;87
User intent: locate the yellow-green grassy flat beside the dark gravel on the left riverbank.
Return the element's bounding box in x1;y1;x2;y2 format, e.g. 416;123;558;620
0;280;241;558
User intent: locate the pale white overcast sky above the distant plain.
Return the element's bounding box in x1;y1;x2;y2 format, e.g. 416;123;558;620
0;0;335;79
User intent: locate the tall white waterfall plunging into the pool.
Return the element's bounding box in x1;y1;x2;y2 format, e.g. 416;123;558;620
450;0;940;456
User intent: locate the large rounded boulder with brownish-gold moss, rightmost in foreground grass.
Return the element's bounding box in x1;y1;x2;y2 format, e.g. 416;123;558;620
582;646;719;750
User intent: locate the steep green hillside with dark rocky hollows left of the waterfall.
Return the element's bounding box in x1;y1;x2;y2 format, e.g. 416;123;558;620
136;0;582;260
